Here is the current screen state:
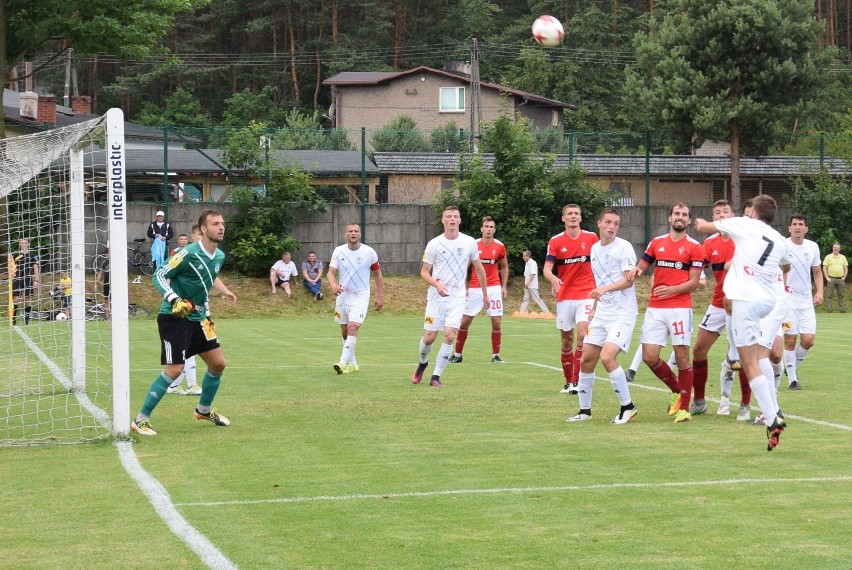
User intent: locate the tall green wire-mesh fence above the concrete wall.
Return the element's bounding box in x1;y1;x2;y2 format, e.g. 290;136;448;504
121;126;852;208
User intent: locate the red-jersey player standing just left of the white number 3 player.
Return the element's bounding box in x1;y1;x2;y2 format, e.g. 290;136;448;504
543;204;599;394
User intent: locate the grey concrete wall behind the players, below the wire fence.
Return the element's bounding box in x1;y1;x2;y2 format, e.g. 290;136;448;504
95;203;789;274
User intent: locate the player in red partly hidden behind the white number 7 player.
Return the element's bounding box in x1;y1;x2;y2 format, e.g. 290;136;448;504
689;200;751;421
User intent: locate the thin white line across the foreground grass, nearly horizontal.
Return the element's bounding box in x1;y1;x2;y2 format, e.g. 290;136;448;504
177;476;852;507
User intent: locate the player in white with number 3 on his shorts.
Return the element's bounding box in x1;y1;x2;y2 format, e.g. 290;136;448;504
567;208;639;424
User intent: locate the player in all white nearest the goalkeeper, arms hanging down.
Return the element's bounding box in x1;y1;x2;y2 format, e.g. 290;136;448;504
327;223;385;374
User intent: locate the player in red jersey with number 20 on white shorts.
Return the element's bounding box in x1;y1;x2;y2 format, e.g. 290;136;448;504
450;216;509;364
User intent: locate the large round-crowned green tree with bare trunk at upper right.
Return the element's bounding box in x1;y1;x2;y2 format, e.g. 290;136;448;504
627;0;822;209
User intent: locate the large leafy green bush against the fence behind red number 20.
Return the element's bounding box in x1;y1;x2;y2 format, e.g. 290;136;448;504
436;117;607;270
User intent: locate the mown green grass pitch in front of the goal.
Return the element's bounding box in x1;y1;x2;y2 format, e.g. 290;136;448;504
0;313;852;569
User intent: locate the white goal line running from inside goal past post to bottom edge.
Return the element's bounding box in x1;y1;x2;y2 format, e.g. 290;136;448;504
13;326;237;569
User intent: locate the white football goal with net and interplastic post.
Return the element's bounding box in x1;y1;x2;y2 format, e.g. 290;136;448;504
0;109;129;446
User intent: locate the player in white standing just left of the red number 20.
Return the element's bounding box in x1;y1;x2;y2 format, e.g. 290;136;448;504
411;206;490;386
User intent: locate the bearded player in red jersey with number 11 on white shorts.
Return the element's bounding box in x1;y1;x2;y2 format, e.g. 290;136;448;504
633;202;704;422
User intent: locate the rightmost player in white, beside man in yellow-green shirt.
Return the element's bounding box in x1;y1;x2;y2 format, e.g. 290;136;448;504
784;214;823;390
